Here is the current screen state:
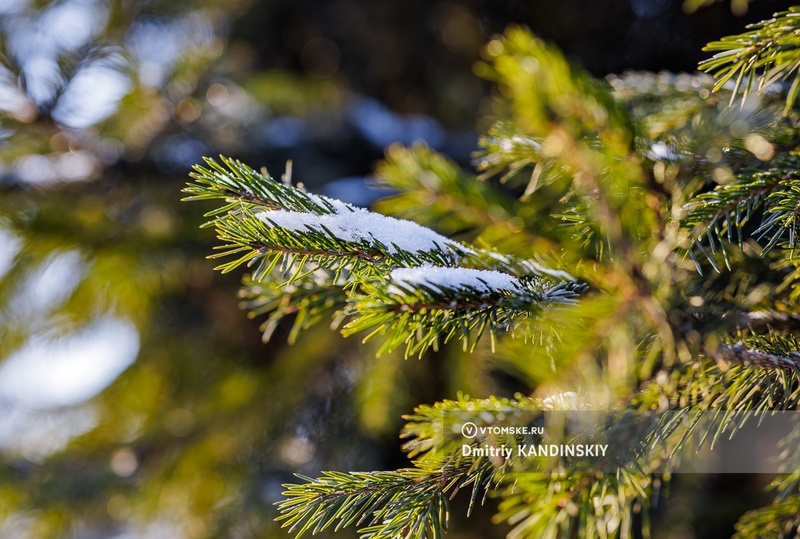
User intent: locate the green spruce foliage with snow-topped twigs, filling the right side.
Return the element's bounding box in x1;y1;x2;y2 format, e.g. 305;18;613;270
186;10;800;539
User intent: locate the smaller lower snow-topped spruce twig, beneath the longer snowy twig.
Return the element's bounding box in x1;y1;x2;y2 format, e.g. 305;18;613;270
343;266;583;357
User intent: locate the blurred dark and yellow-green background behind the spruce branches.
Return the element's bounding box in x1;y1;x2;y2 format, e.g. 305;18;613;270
0;0;788;539
